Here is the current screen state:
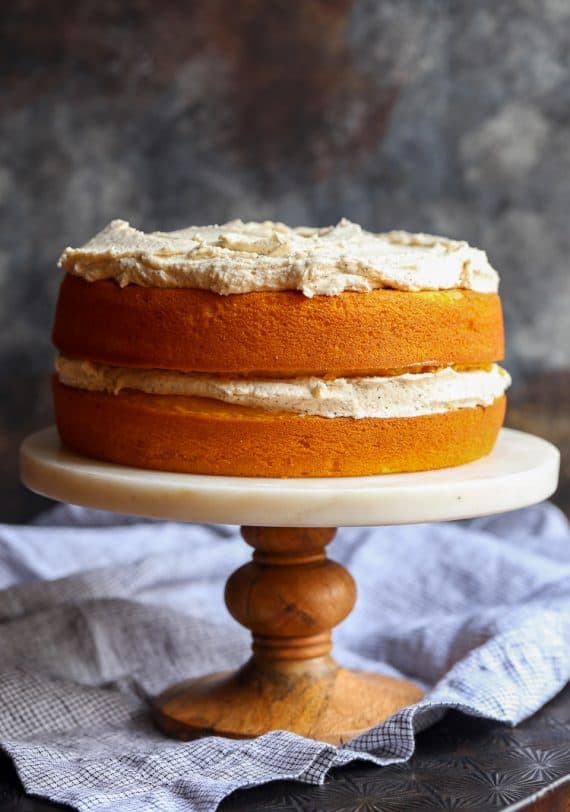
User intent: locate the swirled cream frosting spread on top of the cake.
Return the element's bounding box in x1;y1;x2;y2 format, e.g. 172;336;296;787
60;219;499;297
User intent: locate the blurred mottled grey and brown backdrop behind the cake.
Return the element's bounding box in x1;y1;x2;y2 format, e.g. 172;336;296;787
0;0;570;520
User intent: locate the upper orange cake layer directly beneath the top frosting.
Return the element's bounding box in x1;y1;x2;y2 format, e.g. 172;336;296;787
53;274;504;378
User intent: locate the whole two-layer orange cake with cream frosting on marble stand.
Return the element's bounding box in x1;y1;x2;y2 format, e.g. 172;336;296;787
53;220;510;477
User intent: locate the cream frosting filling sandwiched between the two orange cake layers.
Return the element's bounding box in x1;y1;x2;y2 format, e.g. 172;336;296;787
56;355;511;419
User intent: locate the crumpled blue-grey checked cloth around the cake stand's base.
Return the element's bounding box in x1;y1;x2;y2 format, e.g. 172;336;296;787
0;504;570;812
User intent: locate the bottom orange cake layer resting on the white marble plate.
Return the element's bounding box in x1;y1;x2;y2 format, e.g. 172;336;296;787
53;377;506;477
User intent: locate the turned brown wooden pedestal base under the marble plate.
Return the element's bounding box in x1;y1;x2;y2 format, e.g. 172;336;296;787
154;527;422;743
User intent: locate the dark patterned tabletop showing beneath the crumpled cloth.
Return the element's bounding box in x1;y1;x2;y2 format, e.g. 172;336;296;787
0;686;570;812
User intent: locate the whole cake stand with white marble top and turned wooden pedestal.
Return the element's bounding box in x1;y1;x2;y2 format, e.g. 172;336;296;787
21;428;559;743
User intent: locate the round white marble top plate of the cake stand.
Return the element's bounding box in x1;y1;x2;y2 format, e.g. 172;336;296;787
21;427;560;527
